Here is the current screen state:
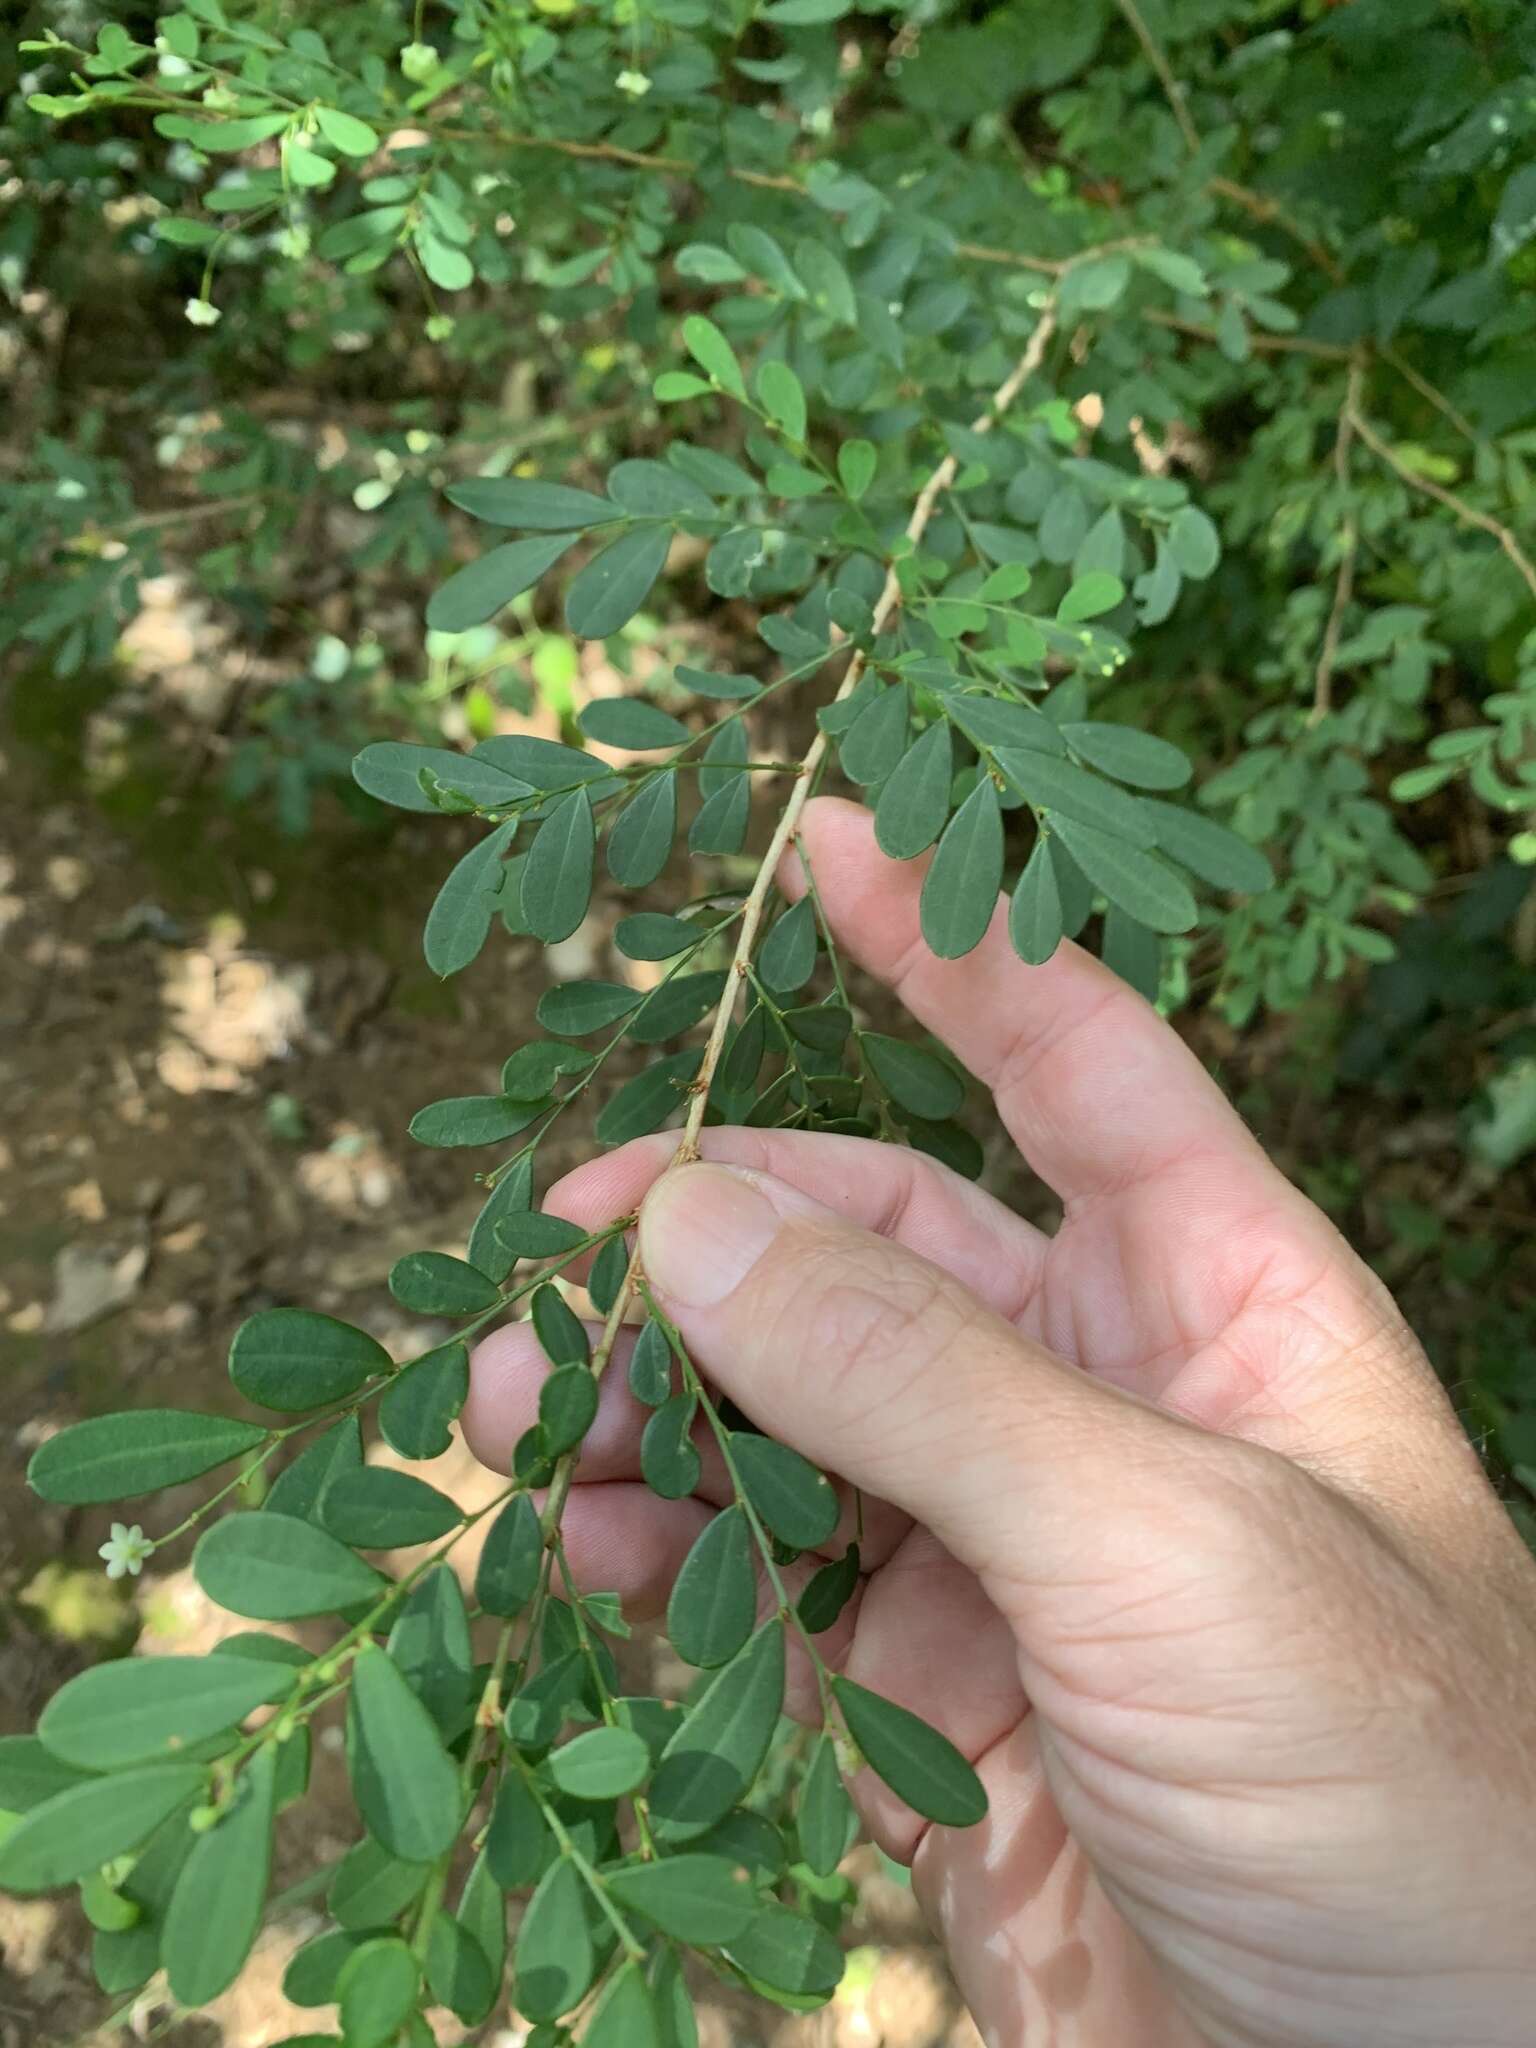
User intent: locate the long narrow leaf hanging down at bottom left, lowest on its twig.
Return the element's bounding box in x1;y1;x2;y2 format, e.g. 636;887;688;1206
160;1747;276;2005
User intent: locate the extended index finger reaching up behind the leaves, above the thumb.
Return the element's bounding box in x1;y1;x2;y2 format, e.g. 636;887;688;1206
780;797;1292;1208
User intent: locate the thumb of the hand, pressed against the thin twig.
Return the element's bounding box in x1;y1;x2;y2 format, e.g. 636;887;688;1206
639;1165;1231;1620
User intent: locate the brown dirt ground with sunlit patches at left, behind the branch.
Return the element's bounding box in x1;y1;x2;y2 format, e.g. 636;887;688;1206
0;684;999;2048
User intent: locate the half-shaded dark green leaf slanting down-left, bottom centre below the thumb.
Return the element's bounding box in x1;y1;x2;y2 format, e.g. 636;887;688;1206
649;1616;784;1841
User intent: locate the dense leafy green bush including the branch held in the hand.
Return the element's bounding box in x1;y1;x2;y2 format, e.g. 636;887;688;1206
0;0;1536;2048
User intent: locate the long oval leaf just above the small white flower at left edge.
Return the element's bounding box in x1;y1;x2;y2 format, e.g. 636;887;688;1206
27;1409;266;1507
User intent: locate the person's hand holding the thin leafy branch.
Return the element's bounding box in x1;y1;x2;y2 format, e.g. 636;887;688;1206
465;801;1536;2048
